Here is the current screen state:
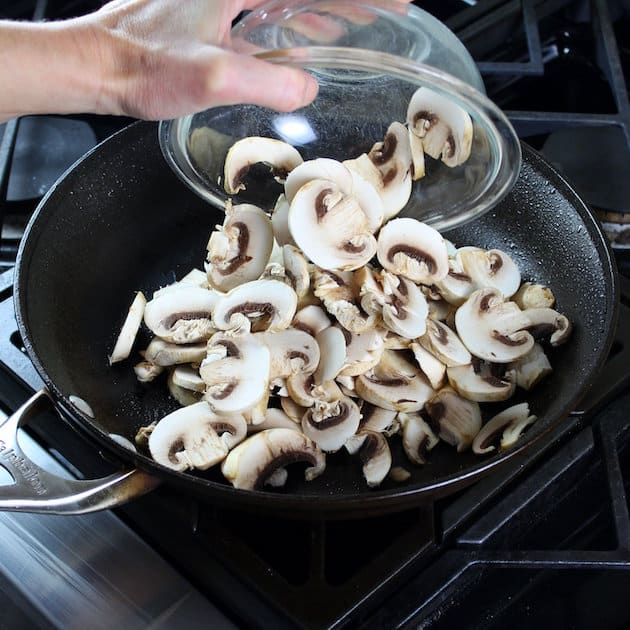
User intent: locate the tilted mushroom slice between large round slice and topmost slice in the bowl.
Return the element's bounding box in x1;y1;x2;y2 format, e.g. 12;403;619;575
343;122;412;221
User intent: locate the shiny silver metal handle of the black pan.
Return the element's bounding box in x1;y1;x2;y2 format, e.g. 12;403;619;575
0;389;159;514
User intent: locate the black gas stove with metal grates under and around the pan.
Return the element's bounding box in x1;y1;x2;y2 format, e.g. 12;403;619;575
0;0;630;629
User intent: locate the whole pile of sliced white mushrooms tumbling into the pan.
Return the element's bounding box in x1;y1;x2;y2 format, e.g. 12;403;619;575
110;88;571;489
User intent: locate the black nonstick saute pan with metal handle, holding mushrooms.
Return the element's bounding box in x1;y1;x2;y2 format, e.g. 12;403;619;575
8;123;618;517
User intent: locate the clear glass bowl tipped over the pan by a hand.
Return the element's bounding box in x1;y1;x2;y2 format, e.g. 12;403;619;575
159;0;521;230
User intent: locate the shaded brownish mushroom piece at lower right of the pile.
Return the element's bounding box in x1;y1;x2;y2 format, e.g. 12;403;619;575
425;387;481;452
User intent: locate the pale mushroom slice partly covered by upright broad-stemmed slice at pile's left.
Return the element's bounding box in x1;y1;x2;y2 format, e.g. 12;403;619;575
253;328;320;380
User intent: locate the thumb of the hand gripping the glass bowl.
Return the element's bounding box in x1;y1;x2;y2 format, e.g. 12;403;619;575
208;51;319;112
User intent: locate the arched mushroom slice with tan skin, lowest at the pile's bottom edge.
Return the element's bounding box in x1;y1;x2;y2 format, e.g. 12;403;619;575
221;429;326;490
